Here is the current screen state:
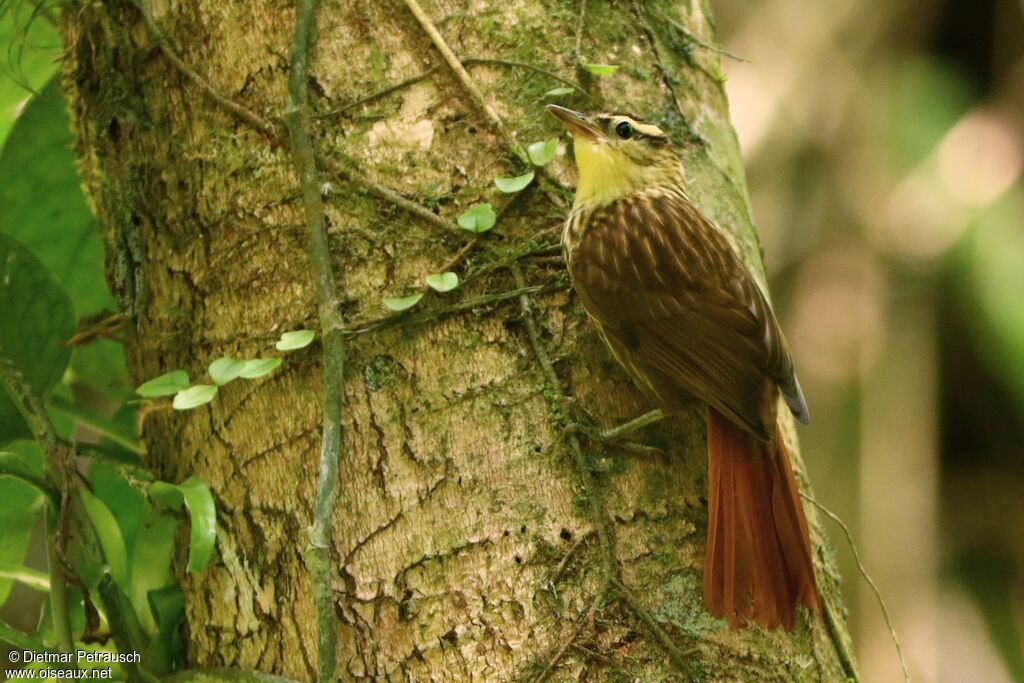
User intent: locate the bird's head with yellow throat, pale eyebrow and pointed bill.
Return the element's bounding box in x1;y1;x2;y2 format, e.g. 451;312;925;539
547;104;682;206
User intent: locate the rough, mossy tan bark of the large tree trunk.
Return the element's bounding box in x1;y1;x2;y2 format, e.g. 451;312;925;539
65;0;846;681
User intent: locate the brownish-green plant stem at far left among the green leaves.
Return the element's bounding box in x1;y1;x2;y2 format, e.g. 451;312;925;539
0;355;74;652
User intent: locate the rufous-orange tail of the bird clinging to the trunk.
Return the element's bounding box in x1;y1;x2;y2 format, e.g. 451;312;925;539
705;408;820;631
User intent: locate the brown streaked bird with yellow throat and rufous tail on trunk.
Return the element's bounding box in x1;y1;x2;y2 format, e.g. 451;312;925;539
547;104;820;631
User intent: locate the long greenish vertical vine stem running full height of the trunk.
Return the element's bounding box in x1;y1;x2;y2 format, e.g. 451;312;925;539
286;0;345;683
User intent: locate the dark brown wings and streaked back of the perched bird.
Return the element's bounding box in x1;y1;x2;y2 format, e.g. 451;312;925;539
570;193;807;439
